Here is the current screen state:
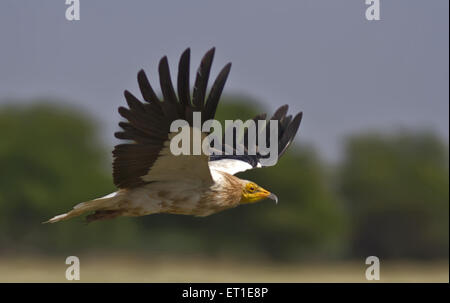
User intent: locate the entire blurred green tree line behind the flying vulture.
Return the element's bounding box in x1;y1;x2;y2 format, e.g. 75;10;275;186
0;97;449;261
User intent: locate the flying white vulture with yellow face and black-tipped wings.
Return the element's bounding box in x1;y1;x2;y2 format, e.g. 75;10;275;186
45;48;302;223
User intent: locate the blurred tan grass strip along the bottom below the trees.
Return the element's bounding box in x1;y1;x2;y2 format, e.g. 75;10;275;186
0;255;449;283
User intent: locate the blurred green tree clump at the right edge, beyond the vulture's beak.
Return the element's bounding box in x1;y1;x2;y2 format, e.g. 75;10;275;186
338;133;449;258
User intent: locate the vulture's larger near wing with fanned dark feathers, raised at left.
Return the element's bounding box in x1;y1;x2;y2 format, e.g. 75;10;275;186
113;48;231;188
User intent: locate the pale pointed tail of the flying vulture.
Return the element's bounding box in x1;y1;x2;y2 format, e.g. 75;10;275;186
43;192;120;223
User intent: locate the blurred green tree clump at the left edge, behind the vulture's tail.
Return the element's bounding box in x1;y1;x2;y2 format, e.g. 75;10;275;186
0;104;140;252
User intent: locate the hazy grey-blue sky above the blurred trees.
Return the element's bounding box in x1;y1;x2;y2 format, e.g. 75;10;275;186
0;0;449;159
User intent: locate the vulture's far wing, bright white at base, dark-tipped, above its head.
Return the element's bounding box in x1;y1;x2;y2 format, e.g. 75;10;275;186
209;105;303;175
